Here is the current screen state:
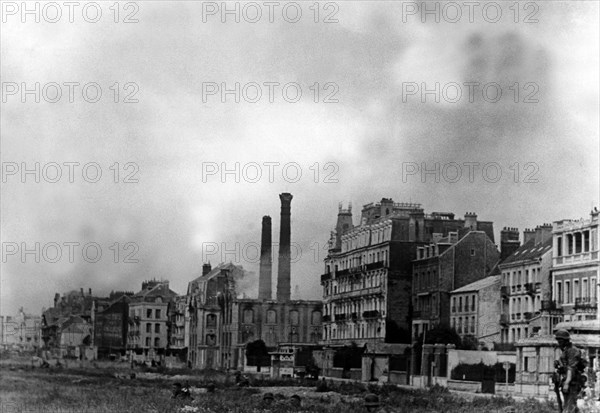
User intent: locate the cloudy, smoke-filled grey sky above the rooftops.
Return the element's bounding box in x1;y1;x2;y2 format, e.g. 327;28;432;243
0;1;600;314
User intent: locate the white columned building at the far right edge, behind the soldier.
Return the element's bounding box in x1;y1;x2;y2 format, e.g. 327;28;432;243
550;208;600;321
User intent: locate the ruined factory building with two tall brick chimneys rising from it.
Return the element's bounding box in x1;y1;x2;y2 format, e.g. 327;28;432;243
186;193;322;369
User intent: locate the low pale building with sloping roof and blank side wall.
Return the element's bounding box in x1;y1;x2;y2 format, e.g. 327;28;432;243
450;275;501;349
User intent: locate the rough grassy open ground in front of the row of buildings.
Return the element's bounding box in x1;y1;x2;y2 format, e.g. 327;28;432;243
0;366;556;413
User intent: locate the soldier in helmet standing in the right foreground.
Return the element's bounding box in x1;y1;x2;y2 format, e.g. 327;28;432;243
554;330;582;413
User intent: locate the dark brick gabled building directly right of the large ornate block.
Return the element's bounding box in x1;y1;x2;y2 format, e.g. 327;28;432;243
412;231;500;337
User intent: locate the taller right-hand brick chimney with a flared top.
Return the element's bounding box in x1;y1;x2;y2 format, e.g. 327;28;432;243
277;192;293;302
